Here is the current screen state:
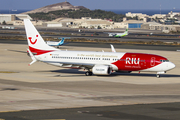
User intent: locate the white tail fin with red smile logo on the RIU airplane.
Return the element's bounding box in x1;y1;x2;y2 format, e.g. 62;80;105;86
24;19;57;53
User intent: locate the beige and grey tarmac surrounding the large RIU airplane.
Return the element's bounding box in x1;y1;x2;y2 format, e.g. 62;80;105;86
0;43;180;120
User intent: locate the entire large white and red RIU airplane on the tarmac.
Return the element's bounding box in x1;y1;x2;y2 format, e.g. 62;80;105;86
24;19;175;77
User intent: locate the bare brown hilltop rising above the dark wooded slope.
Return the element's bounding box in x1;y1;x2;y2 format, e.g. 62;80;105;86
23;2;87;14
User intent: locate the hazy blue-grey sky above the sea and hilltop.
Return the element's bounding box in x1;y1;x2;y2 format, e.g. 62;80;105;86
0;0;180;10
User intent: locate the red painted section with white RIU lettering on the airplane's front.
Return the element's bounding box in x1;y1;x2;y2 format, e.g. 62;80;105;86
112;53;167;71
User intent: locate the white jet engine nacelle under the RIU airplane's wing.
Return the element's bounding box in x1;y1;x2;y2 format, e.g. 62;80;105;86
92;65;112;75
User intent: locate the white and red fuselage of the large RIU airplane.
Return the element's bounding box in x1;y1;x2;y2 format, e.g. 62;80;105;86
30;48;175;72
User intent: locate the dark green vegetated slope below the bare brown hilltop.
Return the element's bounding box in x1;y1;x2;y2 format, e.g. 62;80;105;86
29;9;125;22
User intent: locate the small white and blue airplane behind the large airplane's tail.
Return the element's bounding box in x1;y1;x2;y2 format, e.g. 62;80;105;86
46;37;70;48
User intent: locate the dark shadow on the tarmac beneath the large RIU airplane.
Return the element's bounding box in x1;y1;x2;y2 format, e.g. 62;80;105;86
38;69;180;78
